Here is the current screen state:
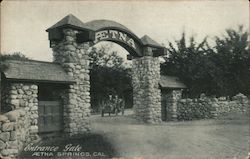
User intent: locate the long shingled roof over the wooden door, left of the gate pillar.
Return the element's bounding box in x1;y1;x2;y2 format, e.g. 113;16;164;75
3;60;75;83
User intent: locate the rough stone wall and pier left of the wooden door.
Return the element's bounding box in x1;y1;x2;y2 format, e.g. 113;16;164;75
0;83;39;158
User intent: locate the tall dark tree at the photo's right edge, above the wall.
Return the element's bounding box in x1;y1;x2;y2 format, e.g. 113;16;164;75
213;26;250;96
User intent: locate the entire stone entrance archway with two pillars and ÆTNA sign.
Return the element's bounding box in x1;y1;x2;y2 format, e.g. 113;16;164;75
46;14;165;135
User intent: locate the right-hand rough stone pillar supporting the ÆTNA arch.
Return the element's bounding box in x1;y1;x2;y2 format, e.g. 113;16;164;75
132;56;161;123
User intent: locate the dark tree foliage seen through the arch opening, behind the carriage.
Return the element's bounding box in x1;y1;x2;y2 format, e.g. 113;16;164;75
90;47;132;110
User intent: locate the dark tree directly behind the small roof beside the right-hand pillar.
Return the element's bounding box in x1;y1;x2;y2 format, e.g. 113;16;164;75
161;33;218;96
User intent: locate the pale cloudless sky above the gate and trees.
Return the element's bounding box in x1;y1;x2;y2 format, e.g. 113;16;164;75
0;0;249;61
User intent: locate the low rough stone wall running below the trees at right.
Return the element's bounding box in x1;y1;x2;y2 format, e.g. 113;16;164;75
177;94;250;120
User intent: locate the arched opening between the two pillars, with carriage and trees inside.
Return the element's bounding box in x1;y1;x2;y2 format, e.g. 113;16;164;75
89;41;133;115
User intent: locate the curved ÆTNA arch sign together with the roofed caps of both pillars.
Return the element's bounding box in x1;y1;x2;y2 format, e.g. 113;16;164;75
47;15;164;57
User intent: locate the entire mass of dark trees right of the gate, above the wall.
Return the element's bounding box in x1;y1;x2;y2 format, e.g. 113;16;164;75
161;27;250;97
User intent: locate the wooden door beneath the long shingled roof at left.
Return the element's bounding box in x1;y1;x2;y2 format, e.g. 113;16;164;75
38;101;63;133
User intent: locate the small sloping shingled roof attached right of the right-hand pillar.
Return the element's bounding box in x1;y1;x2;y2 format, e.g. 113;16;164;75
159;75;187;89
